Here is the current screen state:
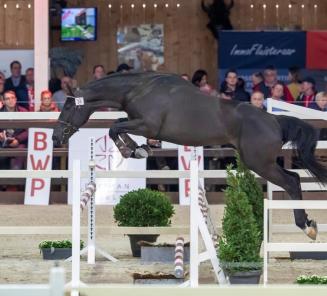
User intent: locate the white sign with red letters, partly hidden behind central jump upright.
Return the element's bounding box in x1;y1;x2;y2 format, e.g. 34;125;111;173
178;145;203;205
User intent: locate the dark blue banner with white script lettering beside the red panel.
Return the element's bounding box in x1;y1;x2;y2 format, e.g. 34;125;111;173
218;31;306;69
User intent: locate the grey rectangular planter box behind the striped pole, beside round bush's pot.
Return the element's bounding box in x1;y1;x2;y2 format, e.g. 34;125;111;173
141;245;190;263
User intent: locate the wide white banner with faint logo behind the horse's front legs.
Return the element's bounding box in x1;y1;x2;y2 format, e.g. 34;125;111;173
68;129;146;205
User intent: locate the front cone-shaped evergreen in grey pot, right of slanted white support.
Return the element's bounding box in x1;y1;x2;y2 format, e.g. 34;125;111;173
217;166;262;284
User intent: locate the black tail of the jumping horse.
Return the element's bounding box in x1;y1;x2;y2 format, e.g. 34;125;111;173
276;115;327;183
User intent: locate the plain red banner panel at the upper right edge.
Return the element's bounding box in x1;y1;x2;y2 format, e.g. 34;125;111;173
306;32;327;70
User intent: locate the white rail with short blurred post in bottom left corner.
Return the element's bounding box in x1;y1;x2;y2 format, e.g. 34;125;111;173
0;267;65;296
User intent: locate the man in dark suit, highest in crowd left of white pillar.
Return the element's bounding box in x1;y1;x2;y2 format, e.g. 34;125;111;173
5;61;28;109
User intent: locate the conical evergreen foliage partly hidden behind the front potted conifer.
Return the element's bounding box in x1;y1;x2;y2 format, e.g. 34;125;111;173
236;153;264;240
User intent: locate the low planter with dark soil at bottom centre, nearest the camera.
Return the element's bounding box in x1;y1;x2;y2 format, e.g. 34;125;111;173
133;273;184;285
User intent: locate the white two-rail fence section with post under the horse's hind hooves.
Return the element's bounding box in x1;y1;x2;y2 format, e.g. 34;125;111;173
263;199;327;284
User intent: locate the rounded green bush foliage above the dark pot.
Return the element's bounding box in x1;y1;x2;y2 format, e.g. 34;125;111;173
114;189;175;227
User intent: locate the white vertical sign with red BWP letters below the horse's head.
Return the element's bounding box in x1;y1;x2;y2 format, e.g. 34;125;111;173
24;128;53;205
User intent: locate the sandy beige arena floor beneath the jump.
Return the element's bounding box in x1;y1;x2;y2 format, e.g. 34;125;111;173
0;205;327;284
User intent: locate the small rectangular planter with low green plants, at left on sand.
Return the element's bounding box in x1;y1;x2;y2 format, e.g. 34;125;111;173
39;240;84;260
